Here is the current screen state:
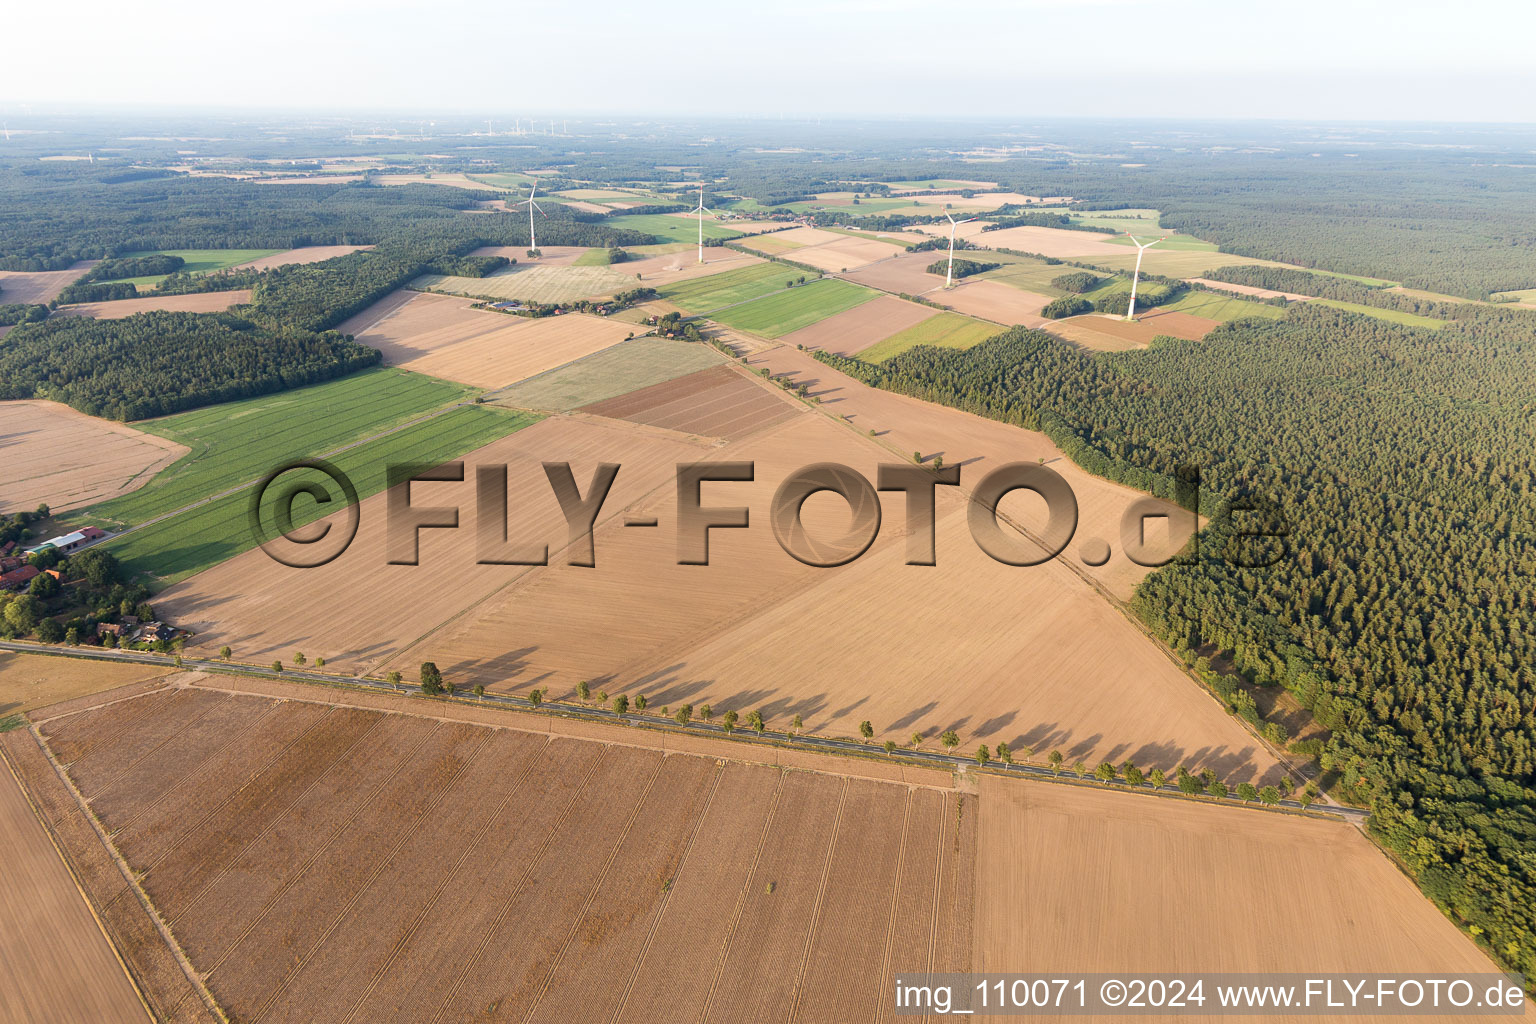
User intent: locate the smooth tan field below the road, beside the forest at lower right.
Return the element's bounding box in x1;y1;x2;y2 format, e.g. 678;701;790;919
975;777;1508;1024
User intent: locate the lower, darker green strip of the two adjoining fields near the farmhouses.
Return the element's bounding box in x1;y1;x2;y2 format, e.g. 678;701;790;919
106;405;539;588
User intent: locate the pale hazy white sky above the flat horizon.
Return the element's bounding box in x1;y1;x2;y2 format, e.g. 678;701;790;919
12;0;1536;121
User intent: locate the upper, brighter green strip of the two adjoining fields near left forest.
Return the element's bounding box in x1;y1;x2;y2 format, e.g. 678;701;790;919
83;368;475;528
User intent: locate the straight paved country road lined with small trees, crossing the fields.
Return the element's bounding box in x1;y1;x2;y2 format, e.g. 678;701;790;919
0;640;1370;824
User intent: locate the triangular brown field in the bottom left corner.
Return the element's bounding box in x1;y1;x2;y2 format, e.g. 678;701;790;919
0;732;152;1024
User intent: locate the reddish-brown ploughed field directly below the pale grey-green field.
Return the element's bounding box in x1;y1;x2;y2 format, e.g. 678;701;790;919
581;365;803;441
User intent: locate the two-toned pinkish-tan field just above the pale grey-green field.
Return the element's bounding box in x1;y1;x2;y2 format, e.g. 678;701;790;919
344;293;634;388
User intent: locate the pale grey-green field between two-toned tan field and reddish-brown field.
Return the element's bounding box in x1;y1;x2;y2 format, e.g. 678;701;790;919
490;338;725;413
